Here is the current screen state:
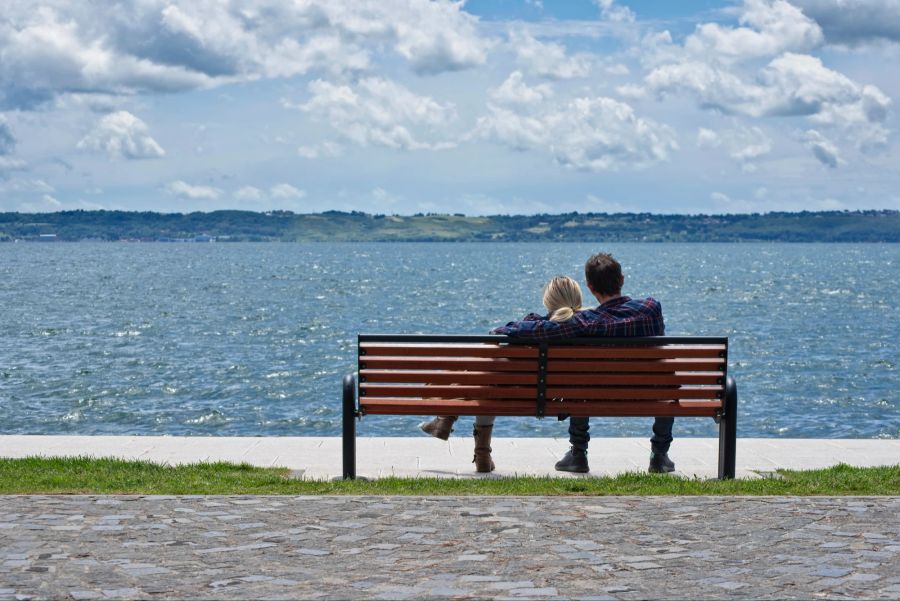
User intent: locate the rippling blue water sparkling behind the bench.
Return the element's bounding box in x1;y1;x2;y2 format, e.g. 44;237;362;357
0;243;900;438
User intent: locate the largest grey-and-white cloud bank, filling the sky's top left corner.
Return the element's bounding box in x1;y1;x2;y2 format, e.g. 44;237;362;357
0;0;492;109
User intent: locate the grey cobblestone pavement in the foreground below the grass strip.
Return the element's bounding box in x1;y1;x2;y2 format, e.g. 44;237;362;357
0;496;900;600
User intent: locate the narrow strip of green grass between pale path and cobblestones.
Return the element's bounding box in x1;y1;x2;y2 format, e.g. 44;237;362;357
0;457;900;496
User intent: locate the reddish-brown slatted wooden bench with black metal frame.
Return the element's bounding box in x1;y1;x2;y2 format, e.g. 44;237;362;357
343;334;737;479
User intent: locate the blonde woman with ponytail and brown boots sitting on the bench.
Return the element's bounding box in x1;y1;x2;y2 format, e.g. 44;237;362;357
419;275;581;472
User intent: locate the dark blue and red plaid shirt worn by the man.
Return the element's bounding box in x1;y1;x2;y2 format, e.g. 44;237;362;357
491;296;666;340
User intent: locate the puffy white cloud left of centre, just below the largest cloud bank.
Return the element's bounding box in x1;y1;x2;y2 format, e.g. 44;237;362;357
298;77;456;150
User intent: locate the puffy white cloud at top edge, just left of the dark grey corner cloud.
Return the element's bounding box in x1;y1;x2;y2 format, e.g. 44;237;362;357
684;0;823;62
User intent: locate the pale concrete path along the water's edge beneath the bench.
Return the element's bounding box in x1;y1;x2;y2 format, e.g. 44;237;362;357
0;435;900;479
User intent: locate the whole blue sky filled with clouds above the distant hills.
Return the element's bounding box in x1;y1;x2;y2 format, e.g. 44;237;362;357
0;0;900;215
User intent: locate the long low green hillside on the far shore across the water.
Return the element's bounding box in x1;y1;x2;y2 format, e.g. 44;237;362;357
0;211;900;242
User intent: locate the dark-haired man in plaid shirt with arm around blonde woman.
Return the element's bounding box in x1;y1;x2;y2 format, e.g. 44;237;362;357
492;253;675;473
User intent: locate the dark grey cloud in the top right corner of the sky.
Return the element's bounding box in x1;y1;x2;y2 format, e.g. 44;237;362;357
791;0;900;46
